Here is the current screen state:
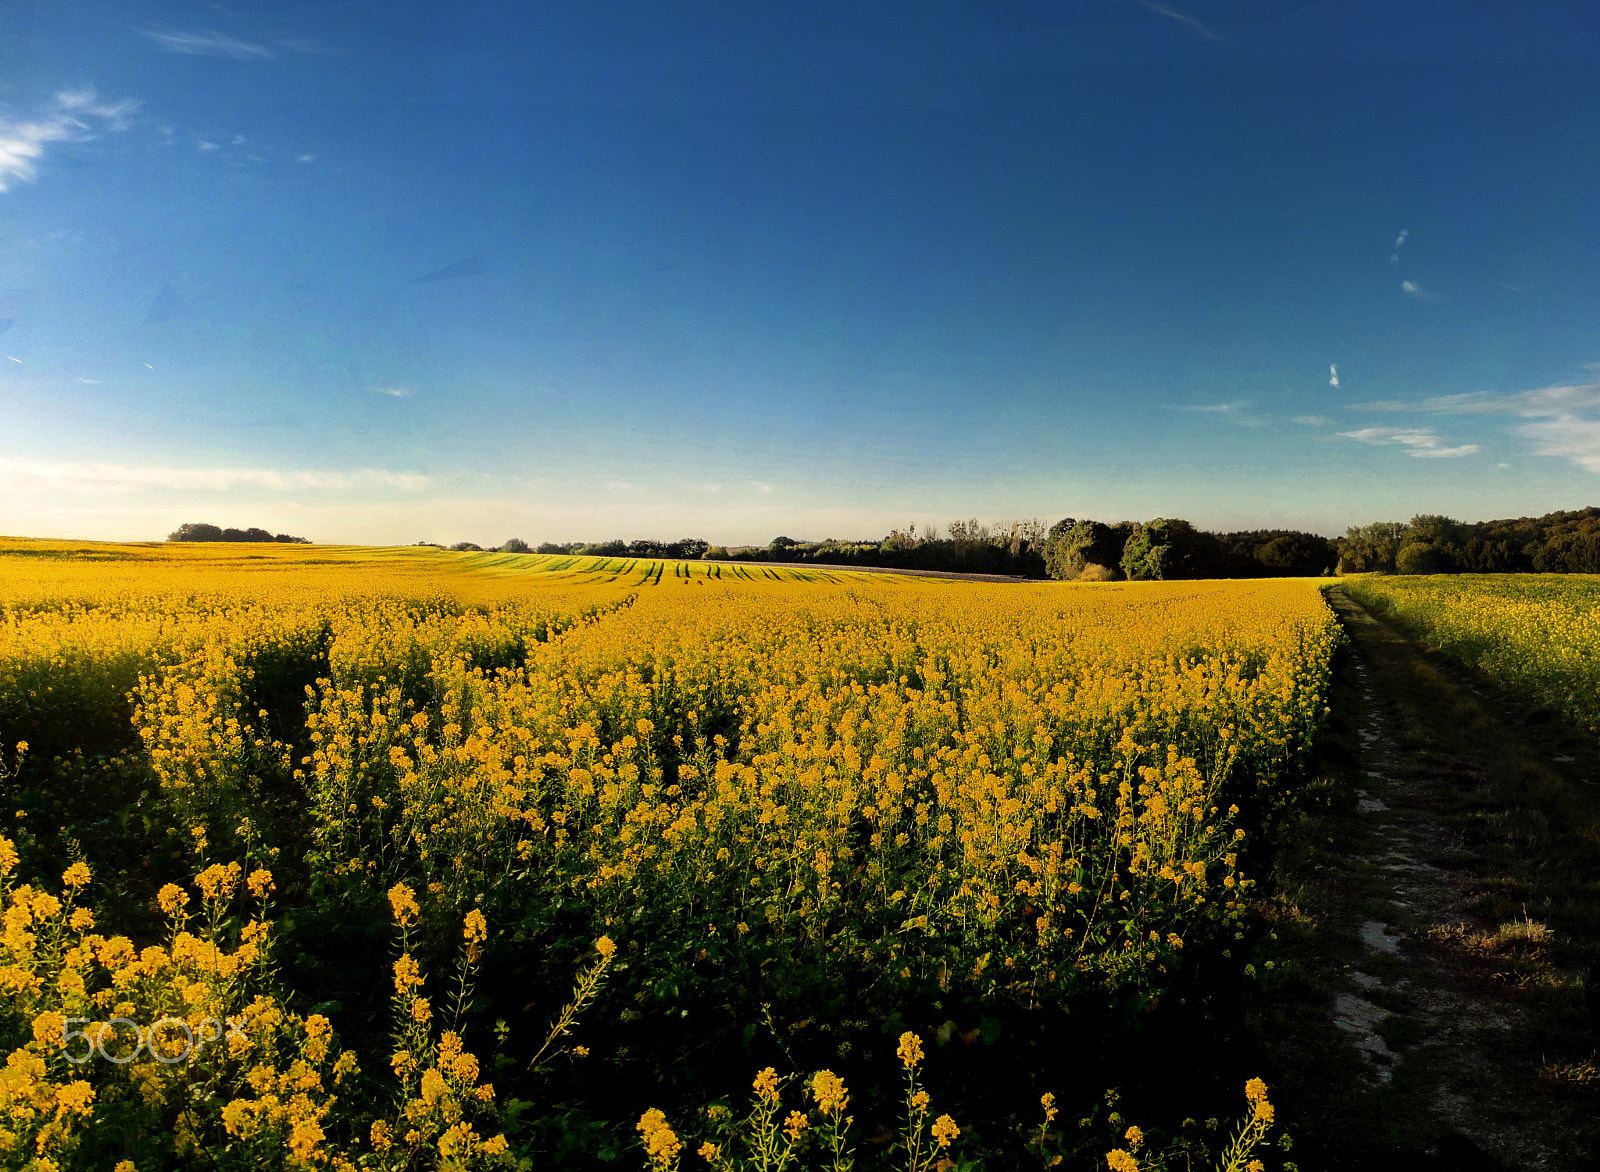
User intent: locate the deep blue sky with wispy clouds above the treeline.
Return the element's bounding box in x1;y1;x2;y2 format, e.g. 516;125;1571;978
0;0;1600;544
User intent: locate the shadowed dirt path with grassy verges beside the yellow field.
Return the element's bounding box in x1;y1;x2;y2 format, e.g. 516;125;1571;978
1258;588;1600;1172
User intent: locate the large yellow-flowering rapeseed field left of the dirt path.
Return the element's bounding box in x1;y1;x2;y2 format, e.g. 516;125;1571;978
0;543;1339;1169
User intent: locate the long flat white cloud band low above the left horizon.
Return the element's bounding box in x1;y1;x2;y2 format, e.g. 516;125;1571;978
0;456;430;495
